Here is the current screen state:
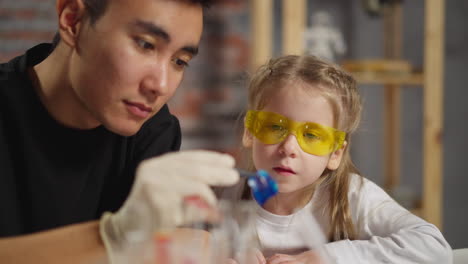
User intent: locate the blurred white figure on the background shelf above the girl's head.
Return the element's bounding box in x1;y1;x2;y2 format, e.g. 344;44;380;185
304;11;346;62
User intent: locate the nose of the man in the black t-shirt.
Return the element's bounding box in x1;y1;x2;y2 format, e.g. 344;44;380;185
141;62;169;99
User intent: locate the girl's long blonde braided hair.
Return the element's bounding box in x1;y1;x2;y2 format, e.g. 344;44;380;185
244;55;362;241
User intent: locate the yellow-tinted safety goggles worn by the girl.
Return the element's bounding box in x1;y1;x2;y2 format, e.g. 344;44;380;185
245;110;346;156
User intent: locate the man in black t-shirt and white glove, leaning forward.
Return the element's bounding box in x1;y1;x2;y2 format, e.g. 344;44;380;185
0;0;238;263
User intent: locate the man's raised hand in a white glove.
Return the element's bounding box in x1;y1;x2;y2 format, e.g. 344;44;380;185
100;150;239;263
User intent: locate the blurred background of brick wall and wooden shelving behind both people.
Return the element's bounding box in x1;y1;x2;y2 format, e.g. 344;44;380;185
0;0;468;248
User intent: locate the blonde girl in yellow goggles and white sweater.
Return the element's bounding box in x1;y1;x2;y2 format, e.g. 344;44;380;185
242;56;452;264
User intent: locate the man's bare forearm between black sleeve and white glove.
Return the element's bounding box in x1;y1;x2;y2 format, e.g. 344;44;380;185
0;221;107;264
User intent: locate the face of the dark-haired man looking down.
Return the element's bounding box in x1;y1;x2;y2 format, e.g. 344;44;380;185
69;0;203;136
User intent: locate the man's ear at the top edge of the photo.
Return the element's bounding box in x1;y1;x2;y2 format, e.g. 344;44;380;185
56;0;86;47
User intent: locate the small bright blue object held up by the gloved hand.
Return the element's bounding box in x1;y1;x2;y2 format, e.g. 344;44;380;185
239;170;278;205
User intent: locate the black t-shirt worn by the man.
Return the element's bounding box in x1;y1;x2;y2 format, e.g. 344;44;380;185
0;44;181;237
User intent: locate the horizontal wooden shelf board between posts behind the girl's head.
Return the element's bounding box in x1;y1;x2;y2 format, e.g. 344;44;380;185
351;72;424;86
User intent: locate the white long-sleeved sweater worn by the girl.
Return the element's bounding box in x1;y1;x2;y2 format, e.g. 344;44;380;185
256;174;452;264
